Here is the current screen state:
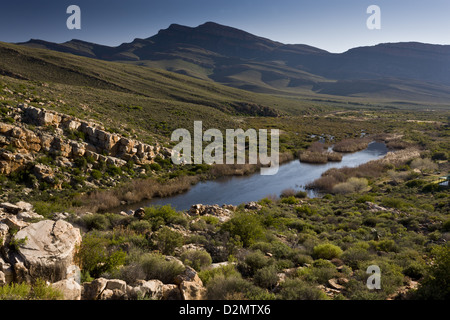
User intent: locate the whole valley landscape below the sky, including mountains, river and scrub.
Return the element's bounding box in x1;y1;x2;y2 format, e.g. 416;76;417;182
0;23;450;300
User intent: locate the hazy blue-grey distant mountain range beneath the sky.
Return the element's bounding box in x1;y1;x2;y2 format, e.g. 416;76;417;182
15;22;450;103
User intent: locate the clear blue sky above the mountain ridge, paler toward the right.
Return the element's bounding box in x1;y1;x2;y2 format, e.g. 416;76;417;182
0;0;450;53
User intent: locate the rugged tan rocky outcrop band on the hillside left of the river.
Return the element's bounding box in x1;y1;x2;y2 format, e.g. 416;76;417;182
0;104;171;190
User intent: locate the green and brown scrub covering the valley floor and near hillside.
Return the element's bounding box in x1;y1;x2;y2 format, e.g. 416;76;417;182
0;38;450;300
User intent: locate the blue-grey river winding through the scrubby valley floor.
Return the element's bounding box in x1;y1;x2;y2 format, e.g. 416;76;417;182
143;142;387;211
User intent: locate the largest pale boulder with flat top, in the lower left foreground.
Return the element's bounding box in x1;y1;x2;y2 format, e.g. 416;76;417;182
14;220;81;282
